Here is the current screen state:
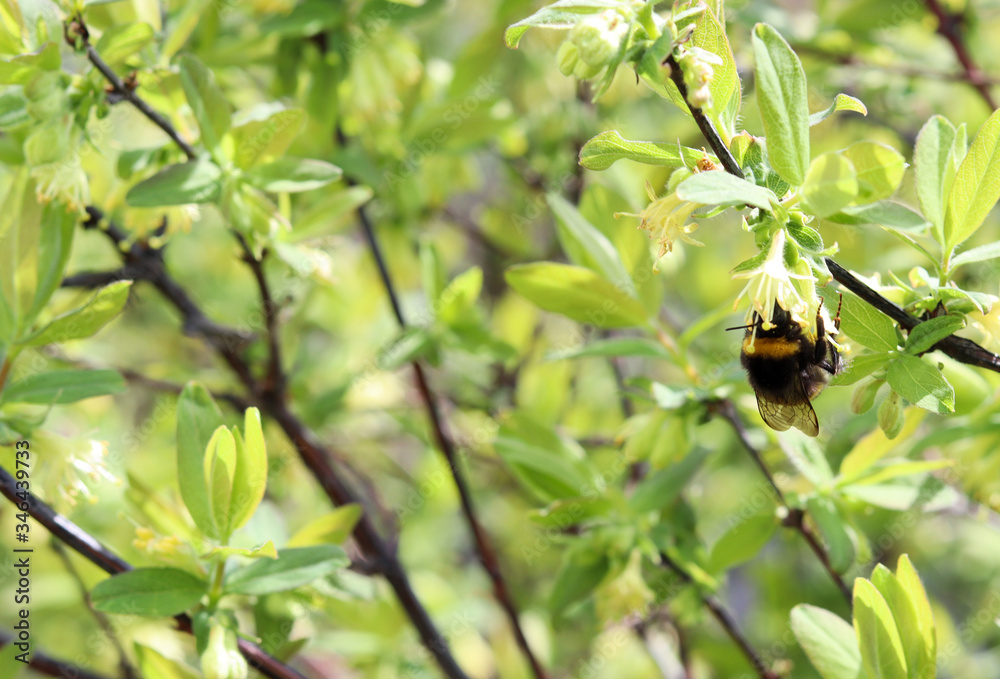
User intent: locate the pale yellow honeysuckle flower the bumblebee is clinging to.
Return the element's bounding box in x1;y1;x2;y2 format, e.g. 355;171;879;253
733;229;819;350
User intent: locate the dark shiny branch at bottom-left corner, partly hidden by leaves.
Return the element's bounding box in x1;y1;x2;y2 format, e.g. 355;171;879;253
0;467;305;679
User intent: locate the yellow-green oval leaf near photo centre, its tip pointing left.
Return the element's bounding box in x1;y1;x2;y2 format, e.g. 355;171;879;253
505;262;648;328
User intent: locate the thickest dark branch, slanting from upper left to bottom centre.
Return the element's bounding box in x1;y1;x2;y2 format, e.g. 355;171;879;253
84;207;467;679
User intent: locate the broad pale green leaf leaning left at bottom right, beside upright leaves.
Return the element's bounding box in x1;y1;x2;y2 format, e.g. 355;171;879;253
791;604;861;679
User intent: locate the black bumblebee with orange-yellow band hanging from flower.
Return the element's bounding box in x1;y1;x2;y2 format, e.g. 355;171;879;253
730;303;840;436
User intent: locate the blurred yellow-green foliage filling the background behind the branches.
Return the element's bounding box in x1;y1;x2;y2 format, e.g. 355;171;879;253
0;0;1000;679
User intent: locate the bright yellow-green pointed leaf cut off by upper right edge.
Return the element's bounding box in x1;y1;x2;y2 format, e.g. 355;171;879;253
944;110;1000;251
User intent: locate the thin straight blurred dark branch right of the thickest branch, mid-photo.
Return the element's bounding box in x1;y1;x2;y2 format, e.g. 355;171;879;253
357;198;547;679
